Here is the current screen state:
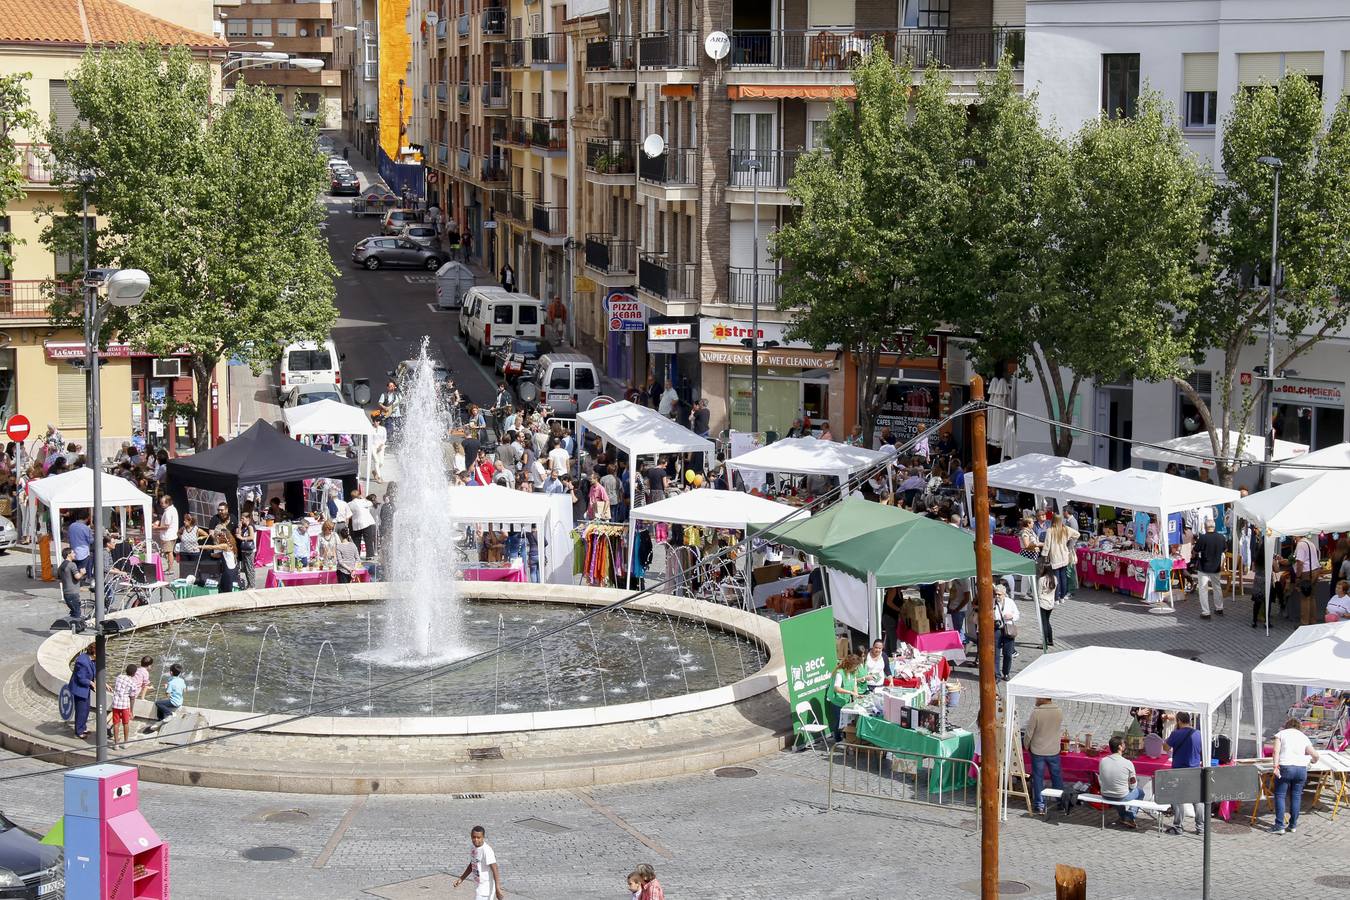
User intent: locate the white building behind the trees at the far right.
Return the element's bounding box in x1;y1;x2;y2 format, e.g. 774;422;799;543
1018;0;1350;468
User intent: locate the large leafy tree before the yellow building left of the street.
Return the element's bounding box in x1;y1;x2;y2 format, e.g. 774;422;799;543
46;46;338;449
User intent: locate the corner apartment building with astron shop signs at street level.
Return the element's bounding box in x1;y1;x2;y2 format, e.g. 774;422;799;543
572;0;1023;436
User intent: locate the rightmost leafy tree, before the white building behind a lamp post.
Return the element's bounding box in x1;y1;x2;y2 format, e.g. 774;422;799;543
1175;73;1350;486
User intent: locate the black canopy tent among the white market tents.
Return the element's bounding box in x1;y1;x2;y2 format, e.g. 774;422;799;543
169;418;356;518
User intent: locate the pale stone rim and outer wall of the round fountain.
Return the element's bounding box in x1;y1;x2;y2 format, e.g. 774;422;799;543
13;583;788;793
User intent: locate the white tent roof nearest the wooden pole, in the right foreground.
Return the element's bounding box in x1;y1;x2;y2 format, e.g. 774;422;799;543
1007;646;1242;715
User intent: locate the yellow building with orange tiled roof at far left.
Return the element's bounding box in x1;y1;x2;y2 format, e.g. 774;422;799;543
0;0;230;453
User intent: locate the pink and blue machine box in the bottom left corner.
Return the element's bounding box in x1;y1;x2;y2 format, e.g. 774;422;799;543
65;765;169;900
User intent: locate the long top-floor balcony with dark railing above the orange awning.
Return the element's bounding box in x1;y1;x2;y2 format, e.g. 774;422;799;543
730;28;1023;74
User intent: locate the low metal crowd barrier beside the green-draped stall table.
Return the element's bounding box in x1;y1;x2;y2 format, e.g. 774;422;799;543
825;742;980;827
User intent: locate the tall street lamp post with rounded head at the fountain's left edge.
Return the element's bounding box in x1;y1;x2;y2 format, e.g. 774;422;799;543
80;184;150;762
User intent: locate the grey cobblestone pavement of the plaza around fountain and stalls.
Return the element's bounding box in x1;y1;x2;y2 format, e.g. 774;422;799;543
0;555;1350;900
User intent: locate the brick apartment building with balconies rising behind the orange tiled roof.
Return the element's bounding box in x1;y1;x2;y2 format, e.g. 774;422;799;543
216;0;342;128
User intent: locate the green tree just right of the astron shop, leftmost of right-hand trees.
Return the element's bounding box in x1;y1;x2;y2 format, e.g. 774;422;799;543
772;45;965;441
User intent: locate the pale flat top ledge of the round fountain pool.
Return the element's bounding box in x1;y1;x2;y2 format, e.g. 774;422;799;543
34;582;786;737
